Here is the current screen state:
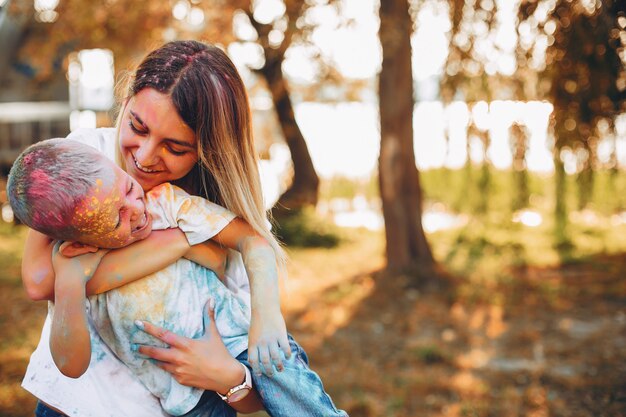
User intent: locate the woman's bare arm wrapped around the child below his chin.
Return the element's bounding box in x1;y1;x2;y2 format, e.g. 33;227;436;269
22;229;189;300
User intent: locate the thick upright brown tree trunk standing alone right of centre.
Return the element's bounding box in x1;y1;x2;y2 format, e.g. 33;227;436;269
378;0;434;270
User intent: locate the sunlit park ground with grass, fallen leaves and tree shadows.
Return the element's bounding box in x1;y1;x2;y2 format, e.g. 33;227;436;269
0;211;626;417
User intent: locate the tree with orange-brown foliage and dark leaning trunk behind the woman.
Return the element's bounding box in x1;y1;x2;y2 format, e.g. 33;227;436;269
3;0;326;209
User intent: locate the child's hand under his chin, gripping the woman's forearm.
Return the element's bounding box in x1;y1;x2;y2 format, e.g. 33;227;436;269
52;242;108;284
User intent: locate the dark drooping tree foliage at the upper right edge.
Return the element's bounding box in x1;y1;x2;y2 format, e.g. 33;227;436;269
518;0;626;246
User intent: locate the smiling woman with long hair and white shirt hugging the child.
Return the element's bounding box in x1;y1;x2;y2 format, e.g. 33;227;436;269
22;42;276;416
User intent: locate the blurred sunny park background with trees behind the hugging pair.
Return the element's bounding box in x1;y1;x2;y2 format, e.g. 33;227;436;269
0;0;626;417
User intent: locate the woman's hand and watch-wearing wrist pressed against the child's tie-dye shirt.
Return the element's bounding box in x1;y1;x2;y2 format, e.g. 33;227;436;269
136;302;263;414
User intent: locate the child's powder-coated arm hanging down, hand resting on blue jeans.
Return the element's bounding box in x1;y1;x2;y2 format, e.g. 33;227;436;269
214;218;291;376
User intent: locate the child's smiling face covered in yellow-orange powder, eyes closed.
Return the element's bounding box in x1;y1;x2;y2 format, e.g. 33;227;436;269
73;156;152;249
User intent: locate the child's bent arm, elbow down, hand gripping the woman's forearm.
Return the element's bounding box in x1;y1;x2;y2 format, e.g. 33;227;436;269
50;242;106;378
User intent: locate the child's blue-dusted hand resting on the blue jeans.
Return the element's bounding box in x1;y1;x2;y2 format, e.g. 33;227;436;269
248;310;291;376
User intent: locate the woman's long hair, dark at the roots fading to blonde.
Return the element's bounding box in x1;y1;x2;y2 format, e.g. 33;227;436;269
117;41;286;266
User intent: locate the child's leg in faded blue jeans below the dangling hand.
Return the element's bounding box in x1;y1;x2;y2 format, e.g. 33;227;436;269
237;335;348;417
